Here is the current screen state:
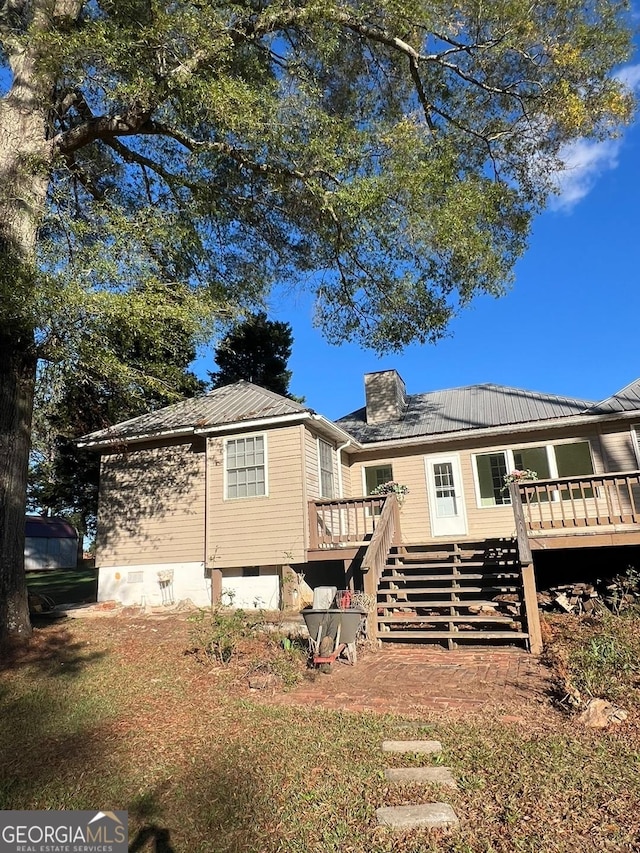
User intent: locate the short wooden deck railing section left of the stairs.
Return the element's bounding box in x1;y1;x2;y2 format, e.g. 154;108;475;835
309;495;388;551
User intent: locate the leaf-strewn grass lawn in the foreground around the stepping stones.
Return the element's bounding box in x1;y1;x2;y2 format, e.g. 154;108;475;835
0;615;640;853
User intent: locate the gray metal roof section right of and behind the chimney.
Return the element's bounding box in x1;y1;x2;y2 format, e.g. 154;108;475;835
336;384;594;444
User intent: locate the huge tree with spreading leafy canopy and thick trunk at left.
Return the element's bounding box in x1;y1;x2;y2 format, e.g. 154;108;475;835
0;0;632;634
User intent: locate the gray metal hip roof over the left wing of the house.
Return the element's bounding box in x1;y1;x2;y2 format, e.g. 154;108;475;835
81;380;311;444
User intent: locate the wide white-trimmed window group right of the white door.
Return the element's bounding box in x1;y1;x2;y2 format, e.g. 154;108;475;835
474;441;593;507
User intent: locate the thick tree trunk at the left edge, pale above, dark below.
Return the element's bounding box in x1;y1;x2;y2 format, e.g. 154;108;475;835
0;0;54;645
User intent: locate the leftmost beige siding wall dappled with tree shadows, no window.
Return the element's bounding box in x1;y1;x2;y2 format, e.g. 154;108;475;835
96;440;204;566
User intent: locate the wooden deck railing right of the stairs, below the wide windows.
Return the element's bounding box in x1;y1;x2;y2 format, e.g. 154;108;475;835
510;471;640;532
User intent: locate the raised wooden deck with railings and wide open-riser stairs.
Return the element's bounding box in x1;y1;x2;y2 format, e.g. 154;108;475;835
308;471;640;654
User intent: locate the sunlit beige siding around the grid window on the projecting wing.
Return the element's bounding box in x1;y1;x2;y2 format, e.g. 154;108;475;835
208;426;304;569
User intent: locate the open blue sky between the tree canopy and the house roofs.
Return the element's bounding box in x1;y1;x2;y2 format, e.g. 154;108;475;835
198;56;640;419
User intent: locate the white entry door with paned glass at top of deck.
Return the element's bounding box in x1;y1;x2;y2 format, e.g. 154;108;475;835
425;453;467;536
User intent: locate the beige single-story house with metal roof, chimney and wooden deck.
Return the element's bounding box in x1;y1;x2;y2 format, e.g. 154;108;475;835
82;370;640;649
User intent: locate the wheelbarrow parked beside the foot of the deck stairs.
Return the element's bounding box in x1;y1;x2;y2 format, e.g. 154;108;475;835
302;608;367;672
